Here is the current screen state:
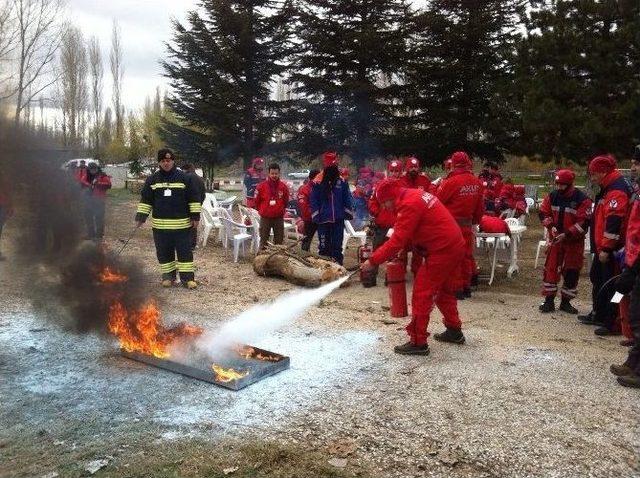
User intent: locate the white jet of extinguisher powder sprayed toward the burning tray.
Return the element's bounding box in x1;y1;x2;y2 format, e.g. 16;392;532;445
195;277;349;356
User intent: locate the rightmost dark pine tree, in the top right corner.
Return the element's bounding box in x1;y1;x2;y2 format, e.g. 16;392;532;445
518;0;640;162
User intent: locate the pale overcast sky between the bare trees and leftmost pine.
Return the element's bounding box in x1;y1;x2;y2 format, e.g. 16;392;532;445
68;0;196;109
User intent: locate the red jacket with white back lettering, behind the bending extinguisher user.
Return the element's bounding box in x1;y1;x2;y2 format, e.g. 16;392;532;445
436;169;484;227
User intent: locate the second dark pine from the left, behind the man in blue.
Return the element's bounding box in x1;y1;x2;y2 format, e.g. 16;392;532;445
284;0;412;165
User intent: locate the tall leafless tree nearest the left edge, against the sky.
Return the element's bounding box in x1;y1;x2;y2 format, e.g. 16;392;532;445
10;0;64;125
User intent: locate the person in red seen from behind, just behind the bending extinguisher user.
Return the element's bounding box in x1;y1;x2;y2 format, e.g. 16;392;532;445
436;151;484;299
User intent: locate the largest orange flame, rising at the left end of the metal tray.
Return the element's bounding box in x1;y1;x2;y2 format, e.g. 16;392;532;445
109;301;202;358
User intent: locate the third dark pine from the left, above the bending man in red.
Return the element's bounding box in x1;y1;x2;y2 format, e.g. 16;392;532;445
405;0;524;163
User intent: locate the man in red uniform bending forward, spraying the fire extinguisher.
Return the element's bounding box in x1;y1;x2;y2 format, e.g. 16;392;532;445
361;179;465;355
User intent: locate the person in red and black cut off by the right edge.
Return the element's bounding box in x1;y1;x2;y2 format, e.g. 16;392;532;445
611;145;640;388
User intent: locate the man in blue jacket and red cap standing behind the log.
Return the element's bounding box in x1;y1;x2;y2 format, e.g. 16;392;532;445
311;152;353;264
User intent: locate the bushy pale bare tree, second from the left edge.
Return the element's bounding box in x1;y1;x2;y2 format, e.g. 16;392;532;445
60;27;89;146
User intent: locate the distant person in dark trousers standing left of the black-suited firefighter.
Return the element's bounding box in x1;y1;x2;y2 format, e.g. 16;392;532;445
80;163;111;240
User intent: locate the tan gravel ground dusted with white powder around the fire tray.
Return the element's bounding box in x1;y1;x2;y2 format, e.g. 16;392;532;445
0;192;640;477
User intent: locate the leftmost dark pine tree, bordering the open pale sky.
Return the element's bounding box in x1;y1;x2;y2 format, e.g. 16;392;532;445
163;0;289;168
